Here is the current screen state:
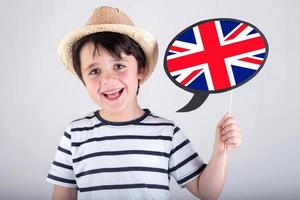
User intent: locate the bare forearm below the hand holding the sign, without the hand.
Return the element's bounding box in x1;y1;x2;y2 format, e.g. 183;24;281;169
198;151;227;200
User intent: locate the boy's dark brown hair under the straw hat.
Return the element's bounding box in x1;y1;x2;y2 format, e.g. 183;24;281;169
72;32;146;85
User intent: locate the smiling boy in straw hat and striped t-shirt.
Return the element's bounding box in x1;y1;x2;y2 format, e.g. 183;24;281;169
47;7;241;200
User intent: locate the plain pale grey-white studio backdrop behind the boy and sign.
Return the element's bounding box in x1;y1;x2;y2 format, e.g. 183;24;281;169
0;0;300;200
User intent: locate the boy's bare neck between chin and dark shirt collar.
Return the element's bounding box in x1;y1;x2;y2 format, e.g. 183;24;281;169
99;106;145;122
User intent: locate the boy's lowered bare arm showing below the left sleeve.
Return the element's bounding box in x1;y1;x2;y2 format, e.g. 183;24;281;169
52;185;77;200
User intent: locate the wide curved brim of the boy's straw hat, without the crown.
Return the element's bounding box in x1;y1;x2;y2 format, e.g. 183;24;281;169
57;24;158;83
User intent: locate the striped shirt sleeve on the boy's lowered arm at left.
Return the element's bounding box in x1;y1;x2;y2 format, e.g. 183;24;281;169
46;127;77;188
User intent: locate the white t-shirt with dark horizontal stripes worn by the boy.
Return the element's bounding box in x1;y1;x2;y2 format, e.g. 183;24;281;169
47;109;206;200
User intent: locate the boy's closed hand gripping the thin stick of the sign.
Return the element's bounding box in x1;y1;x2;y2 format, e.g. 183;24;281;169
214;113;242;153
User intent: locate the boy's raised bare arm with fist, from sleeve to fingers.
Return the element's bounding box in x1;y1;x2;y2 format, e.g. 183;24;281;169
186;114;241;199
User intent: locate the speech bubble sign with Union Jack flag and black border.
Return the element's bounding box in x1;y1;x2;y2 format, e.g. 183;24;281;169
164;18;269;112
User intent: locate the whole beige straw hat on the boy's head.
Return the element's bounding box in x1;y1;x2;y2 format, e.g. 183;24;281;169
57;6;158;83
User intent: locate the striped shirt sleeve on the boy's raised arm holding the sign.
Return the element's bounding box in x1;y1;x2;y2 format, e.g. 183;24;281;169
169;126;206;188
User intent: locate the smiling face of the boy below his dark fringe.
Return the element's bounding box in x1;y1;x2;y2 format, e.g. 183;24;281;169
80;42;143;114
